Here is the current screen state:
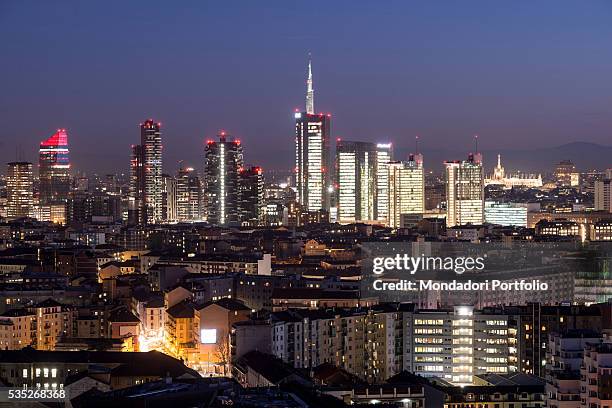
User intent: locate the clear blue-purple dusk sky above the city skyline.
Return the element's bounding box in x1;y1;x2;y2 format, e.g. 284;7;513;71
0;0;612;172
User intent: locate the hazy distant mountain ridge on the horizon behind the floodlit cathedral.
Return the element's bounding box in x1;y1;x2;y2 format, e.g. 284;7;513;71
404;142;612;173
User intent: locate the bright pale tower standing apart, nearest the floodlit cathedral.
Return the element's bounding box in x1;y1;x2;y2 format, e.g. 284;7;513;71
444;153;484;227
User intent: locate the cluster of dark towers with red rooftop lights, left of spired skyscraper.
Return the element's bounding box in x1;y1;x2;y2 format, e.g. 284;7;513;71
128;119;263;226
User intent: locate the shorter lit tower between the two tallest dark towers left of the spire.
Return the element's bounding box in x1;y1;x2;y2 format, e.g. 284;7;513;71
176;167;202;221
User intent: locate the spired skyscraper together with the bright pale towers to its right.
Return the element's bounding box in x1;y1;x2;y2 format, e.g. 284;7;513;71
295;57;484;228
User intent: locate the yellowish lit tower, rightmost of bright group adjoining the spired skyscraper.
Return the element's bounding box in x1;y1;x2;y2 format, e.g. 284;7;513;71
387;154;425;228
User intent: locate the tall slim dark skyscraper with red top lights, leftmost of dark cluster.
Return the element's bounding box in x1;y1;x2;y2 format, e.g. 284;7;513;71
130;119;164;224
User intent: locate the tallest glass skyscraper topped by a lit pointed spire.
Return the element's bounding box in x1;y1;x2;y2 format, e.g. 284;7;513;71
295;57;333;212
